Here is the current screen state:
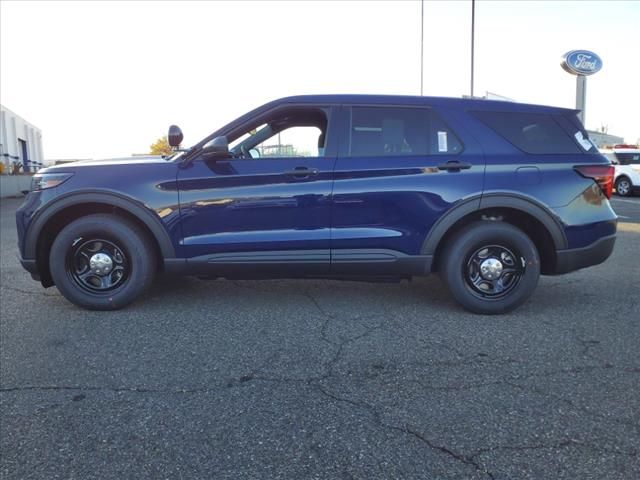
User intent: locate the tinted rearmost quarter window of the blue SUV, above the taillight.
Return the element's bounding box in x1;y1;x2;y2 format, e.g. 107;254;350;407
474;112;583;154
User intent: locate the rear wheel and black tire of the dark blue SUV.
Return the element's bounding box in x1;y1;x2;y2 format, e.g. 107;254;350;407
440;221;540;315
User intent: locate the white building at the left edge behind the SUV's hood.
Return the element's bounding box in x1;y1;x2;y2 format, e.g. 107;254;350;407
0;105;44;173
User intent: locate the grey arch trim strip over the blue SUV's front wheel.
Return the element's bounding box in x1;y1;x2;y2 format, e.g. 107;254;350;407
24;190;176;258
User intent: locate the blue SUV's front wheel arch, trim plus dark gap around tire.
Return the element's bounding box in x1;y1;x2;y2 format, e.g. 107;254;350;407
25;192;175;286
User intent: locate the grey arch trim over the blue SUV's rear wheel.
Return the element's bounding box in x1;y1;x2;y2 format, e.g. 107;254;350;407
422;193;567;255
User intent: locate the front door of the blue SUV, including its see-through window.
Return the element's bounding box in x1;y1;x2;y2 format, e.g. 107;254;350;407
178;107;336;277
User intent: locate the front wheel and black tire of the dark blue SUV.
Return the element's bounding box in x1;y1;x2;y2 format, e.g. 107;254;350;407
49;214;157;310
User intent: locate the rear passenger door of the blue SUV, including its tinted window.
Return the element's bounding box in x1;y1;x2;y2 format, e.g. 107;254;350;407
331;105;485;274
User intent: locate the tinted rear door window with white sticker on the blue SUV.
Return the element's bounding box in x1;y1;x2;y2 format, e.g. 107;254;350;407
349;107;462;157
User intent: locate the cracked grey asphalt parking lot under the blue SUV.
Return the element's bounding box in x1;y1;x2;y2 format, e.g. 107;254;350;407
0;198;640;480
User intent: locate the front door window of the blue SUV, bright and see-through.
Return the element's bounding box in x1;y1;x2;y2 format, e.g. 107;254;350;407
229;107;328;158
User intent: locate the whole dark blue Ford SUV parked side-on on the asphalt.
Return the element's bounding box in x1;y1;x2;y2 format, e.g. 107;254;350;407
17;95;617;314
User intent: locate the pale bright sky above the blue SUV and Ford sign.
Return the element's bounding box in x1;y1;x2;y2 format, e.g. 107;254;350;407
0;0;640;160
